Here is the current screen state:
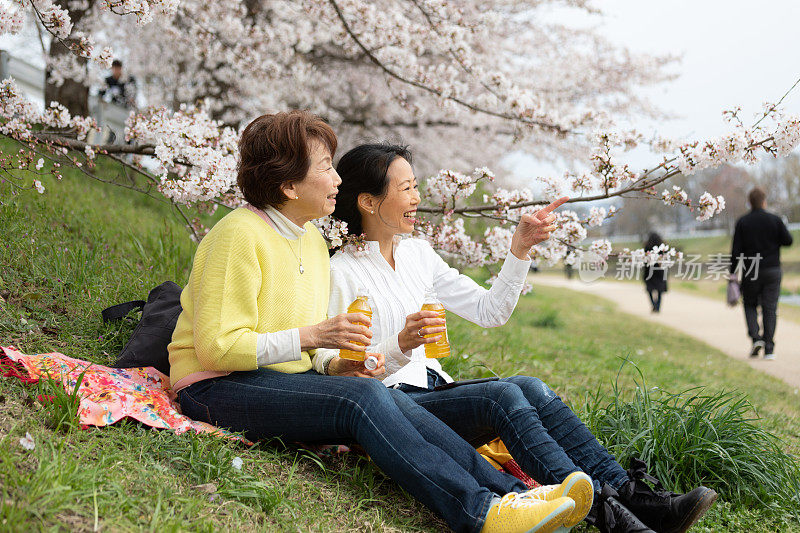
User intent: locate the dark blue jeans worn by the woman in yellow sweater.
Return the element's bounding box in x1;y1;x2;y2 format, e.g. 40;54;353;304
178;368;525;532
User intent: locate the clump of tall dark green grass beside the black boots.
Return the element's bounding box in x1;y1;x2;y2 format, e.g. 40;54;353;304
583;362;800;519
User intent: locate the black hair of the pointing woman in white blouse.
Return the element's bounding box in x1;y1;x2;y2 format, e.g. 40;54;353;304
333;143;411;235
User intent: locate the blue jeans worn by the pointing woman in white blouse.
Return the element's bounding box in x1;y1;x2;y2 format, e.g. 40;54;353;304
400;370;628;491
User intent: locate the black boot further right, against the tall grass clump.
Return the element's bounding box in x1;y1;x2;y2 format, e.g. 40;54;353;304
618;459;717;533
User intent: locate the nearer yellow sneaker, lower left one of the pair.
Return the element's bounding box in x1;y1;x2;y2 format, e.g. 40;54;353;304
481;492;575;533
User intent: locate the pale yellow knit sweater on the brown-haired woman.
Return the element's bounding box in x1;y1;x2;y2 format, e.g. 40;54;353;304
169;209;330;383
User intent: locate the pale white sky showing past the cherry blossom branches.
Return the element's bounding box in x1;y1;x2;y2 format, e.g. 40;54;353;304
504;0;800;182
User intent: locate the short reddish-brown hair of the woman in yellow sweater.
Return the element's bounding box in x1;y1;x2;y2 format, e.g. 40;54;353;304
236;111;337;209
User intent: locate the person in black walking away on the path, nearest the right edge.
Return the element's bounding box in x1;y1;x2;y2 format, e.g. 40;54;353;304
730;187;792;359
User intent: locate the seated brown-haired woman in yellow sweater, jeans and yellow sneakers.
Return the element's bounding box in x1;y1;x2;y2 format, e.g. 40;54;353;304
169;111;575;533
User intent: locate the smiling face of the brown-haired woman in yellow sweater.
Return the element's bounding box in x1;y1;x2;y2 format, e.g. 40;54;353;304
279;139;342;222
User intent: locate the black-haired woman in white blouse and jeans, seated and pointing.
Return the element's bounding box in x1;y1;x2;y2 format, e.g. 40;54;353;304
324;144;716;532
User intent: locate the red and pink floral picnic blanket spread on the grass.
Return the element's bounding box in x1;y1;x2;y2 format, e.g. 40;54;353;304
0;346;251;444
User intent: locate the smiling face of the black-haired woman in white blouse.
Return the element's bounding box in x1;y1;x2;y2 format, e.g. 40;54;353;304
359;157;420;236
